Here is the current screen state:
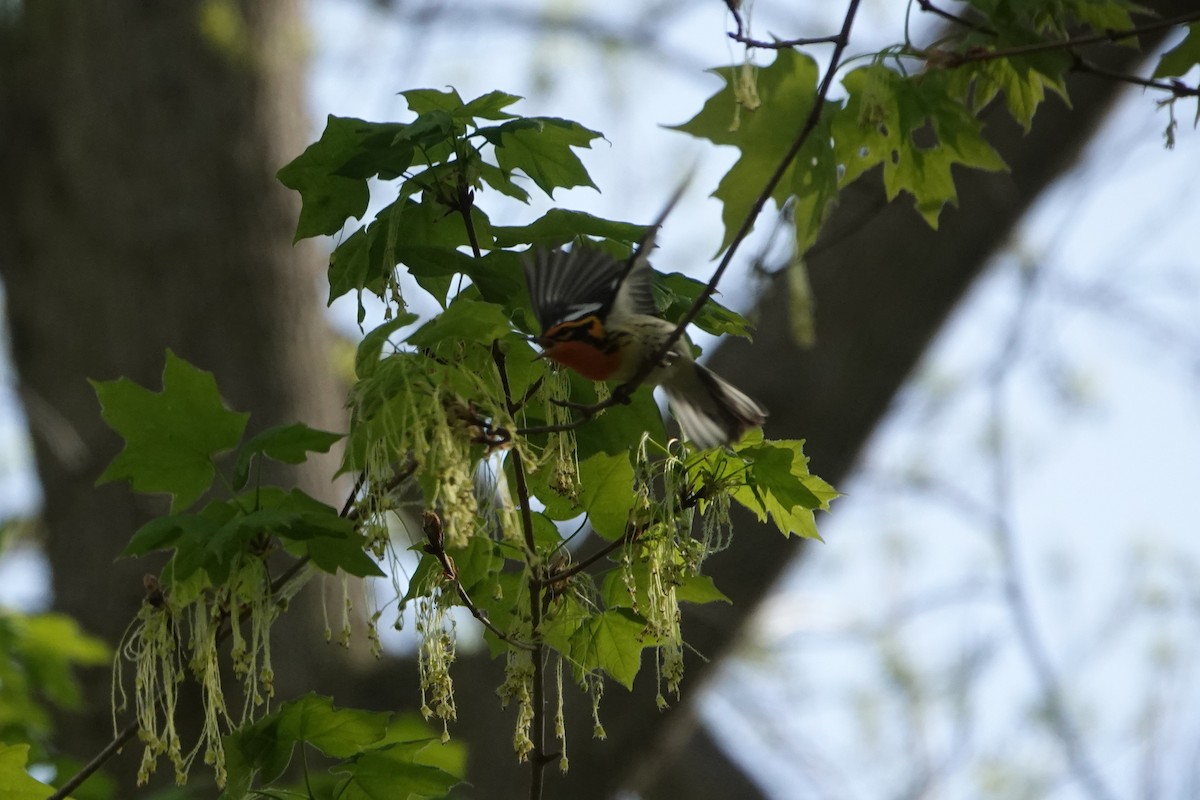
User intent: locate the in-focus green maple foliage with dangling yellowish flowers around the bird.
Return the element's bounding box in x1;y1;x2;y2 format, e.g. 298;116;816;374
16;0;1196;799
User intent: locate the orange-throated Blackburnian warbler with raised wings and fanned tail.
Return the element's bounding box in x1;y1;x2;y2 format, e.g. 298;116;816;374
524;241;767;447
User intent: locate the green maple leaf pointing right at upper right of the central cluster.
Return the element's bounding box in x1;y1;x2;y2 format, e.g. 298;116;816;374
479;116;600;197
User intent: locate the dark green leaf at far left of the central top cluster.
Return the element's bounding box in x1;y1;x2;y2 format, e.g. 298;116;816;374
278;115;373;241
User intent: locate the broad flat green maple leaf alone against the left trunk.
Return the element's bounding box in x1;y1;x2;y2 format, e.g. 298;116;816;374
91;350;250;509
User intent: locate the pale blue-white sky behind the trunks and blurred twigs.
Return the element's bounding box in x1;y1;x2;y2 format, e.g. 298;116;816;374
0;0;1200;800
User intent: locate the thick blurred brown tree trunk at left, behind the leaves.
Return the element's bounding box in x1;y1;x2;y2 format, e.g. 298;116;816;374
0;0;344;778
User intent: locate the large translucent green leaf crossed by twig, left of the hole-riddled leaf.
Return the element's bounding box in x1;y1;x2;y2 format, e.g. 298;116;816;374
676;49;836;249
